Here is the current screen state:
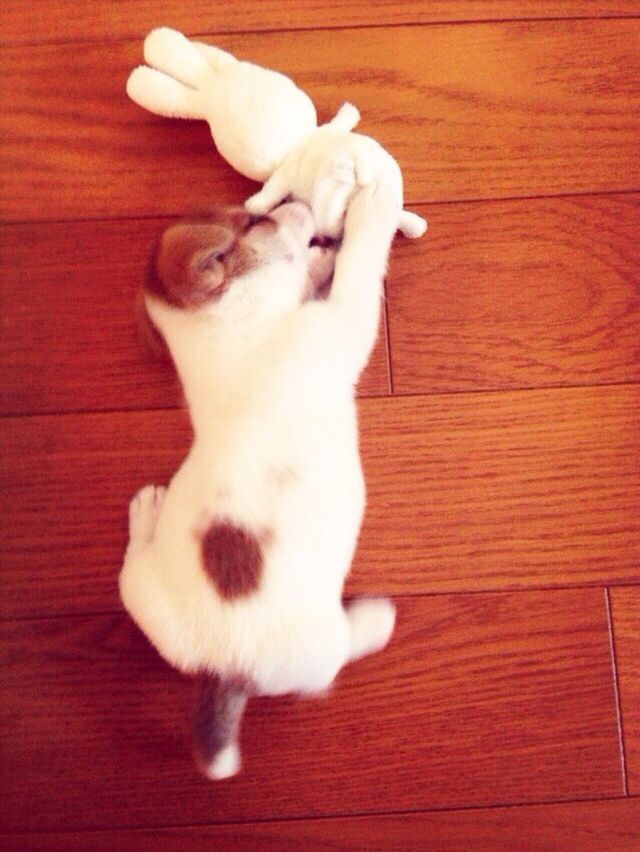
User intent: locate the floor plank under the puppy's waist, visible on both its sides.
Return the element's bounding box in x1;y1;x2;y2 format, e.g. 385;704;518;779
0;386;640;617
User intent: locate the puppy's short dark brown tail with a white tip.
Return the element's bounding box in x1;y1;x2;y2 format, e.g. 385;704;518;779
193;672;251;781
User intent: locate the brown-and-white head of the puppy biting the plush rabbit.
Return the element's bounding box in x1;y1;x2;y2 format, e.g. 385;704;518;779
146;202;333;326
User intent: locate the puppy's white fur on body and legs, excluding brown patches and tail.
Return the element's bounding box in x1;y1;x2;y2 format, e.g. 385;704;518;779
120;188;401;704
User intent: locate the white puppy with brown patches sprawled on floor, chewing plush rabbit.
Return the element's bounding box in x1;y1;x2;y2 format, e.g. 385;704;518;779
120;184;399;778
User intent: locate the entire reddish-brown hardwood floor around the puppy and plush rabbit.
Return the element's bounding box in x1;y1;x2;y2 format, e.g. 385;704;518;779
0;0;640;850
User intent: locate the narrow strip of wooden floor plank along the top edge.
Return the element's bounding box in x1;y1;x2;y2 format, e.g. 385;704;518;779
0;0;638;44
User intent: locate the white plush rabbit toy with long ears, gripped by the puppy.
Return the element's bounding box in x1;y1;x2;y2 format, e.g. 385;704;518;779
127;27;427;237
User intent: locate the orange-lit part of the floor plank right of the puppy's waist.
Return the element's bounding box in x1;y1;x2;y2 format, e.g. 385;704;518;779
354;386;640;591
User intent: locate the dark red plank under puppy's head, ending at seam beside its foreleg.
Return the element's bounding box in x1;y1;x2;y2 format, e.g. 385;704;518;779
0;219;389;414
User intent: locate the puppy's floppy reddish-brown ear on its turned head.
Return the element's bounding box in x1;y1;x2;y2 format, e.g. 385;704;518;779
147;222;236;308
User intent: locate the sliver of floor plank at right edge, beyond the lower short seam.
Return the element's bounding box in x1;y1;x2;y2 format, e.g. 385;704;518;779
610;586;640;792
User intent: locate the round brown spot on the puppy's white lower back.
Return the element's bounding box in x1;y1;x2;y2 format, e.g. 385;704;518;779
201;521;268;600
